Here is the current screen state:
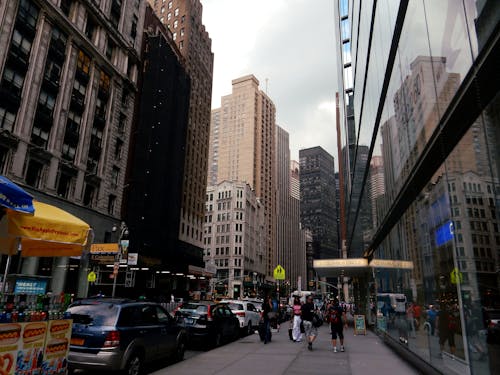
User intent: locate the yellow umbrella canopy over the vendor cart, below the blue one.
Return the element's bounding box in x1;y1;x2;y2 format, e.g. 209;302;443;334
0;201;90;257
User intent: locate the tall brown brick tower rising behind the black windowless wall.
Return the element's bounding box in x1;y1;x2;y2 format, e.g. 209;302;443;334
149;0;214;264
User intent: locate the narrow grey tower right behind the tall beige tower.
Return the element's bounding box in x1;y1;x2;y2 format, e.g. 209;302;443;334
276;126;306;290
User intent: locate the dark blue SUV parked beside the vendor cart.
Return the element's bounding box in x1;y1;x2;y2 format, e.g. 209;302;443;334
64;298;187;375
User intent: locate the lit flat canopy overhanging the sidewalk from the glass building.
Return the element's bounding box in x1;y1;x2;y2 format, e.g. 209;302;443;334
313;258;413;277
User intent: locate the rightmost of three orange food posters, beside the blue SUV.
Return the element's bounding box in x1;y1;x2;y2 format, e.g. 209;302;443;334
40;319;72;375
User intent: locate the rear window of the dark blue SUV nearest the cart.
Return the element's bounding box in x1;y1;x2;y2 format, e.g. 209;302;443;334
68;303;118;326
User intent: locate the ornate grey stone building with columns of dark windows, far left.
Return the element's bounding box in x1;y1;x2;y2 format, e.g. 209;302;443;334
0;0;145;295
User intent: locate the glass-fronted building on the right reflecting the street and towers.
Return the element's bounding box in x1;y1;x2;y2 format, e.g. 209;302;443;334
335;0;500;374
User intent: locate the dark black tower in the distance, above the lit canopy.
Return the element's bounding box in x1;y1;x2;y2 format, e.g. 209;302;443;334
299;146;340;259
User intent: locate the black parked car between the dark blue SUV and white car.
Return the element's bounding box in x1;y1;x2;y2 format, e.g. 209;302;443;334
175;301;240;347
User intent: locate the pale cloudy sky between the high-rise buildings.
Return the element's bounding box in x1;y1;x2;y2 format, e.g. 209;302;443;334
201;0;337;160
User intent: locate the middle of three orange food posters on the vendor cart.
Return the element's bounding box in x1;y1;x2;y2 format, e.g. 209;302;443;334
15;322;47;375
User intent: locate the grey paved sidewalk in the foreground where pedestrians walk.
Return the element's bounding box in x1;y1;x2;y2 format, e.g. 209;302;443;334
153;323;419;375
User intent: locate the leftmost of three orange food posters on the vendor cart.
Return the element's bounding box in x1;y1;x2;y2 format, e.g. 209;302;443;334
0;323;22;375
